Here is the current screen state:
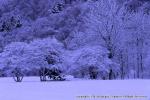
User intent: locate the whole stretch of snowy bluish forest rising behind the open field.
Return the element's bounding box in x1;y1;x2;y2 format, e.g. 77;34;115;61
0;0;150;80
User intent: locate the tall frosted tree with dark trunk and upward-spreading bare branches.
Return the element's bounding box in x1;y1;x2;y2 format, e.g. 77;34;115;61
86;0;120;58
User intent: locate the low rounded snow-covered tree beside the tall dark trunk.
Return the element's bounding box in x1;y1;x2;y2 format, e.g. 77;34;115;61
69;46;119;79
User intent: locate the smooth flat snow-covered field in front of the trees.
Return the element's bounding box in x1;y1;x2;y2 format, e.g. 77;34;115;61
0;77;150;100
